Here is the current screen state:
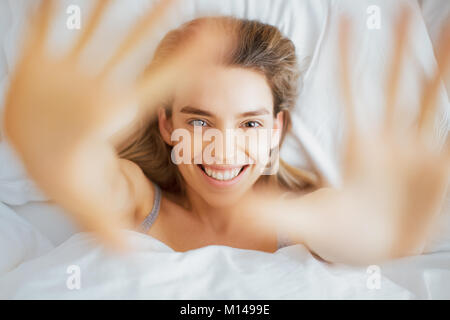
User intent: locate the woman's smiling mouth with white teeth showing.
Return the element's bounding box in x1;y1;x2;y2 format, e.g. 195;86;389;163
197;164;249;186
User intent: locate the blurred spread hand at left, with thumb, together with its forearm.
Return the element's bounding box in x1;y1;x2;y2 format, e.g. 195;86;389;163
3;0;211;250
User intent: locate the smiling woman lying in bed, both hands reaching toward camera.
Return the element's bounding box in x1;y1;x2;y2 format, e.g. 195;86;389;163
4;1;448;263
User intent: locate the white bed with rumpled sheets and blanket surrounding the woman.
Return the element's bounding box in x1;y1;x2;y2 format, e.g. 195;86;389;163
0;0;450;299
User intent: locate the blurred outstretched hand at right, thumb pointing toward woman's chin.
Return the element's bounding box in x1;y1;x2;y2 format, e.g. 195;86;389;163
249;11;450;264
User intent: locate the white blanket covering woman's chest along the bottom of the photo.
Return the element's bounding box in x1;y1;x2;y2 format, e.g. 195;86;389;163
0;222;450;299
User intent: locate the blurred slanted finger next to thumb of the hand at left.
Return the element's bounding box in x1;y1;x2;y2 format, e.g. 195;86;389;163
101;0;175;77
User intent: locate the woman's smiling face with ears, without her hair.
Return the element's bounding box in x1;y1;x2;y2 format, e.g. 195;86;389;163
159;66;283;207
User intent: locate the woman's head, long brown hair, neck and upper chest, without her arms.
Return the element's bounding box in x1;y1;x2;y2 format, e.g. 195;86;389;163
114;17;317;251
